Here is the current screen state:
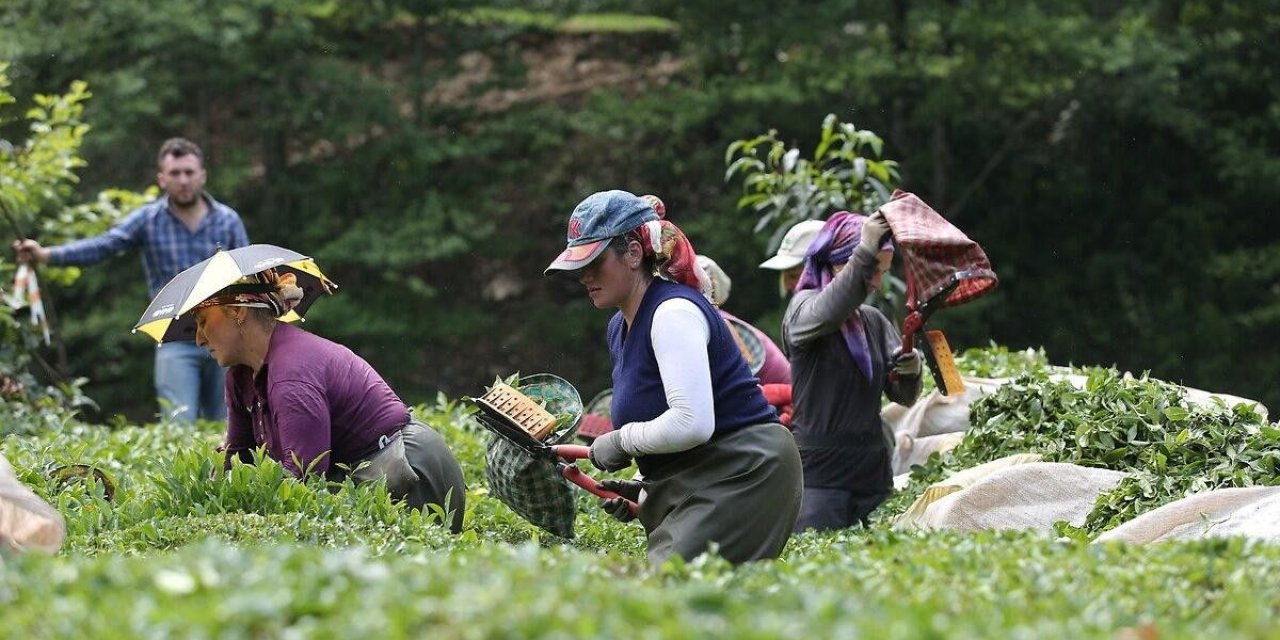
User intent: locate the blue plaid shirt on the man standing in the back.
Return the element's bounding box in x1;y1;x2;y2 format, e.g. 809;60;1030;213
49;193;248;297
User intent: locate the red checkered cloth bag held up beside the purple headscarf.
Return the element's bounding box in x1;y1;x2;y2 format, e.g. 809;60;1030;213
879;189;997;307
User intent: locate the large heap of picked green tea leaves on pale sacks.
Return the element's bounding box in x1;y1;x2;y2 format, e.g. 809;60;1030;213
881;360;1280;535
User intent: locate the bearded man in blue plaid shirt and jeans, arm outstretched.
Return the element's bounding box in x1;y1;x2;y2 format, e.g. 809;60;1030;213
14;138;248;421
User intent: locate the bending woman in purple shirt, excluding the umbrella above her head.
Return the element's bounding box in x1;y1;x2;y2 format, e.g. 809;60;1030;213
195;264;466;532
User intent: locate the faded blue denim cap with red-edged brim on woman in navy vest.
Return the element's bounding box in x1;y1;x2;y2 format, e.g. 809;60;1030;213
543;189;658;275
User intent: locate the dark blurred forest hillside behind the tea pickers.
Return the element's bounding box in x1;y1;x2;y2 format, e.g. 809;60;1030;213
0;0;1280;421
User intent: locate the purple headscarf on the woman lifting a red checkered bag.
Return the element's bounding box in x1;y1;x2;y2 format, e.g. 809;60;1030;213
796;211;893;380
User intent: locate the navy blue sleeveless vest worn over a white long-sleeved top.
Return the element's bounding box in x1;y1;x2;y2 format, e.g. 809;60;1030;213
608;278;778;475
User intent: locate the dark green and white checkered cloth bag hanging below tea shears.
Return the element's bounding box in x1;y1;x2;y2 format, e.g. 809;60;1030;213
484;435;577;538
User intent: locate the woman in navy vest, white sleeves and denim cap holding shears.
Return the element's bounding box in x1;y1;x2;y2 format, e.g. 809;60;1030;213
545;191;803;566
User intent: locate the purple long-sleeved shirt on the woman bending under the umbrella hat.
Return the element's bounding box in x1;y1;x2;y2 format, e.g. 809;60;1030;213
227;323;410;477
